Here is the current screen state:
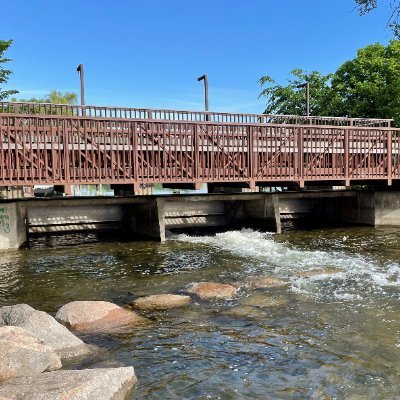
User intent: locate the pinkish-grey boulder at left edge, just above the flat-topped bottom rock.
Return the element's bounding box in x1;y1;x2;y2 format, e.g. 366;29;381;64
0;326;61;382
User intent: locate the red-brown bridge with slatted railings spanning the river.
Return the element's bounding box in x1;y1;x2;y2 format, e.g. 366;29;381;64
0;102;400;188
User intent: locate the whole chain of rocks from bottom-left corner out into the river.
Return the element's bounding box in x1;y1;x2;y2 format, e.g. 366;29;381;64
0;268;338;400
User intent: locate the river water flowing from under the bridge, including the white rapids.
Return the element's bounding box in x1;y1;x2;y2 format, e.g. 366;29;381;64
0;228;400;399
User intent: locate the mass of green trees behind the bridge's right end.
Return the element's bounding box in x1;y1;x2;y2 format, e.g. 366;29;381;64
260;40;400;126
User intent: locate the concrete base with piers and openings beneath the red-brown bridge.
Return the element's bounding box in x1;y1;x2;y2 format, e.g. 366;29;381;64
0;191;400;249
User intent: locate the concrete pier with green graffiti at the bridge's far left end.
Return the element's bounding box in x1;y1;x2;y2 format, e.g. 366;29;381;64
0;203;27;250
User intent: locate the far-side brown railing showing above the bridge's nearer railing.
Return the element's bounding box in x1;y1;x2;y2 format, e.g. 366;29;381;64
0;102;393;127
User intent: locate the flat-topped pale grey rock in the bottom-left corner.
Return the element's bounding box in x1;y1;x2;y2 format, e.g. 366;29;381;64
0;367;137;400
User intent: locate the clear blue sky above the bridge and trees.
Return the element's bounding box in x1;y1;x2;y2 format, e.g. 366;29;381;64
0;0;392;113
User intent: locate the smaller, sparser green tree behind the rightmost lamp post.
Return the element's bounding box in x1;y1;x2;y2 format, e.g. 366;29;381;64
259;68;331;115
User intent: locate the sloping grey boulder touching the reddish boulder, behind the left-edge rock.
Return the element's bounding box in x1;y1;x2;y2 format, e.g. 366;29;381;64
0;304;90;359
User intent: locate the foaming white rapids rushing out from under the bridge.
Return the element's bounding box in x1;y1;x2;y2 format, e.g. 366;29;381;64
170;229;400;301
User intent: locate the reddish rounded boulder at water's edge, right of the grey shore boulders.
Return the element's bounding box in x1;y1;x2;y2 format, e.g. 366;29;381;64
56;301;148;333
